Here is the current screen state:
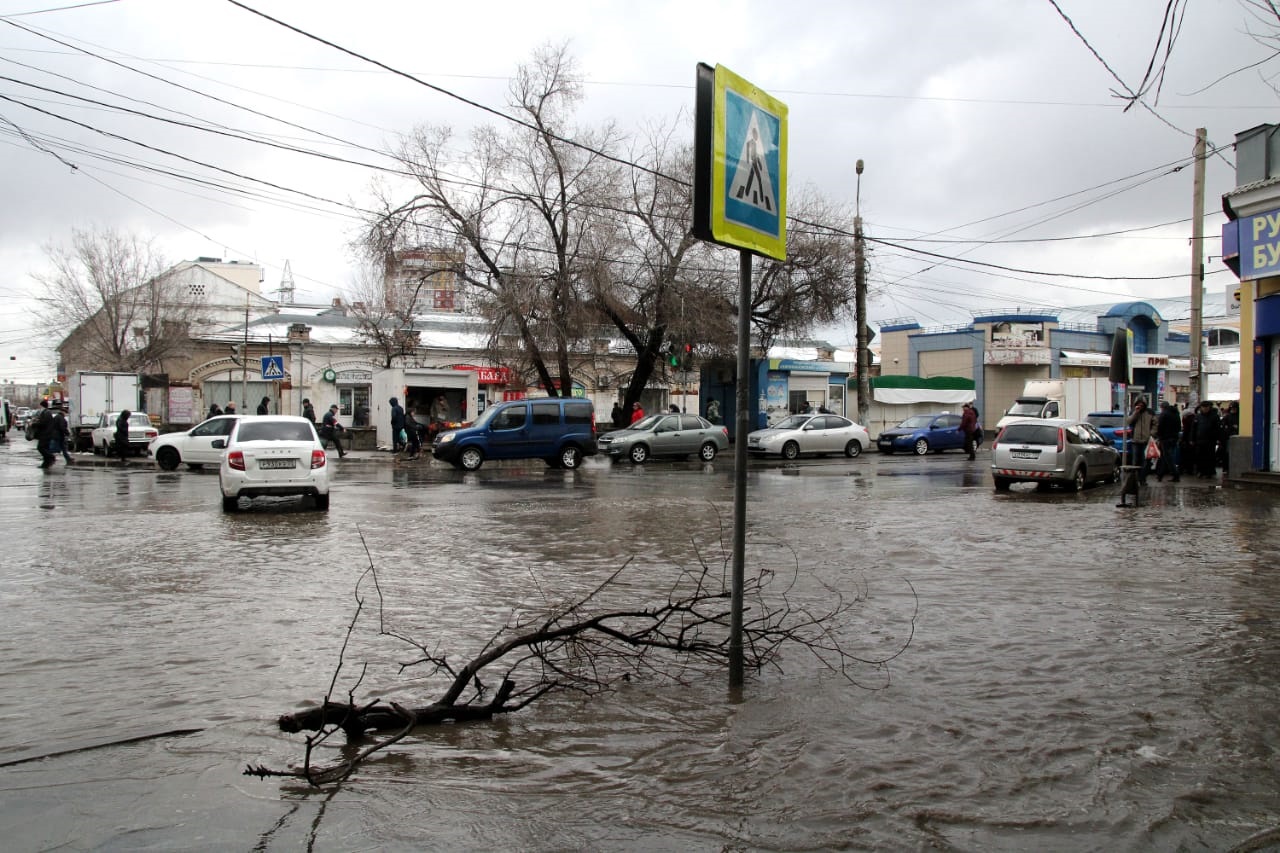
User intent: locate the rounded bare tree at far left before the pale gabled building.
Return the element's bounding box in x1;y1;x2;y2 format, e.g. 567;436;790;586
33;228;204;371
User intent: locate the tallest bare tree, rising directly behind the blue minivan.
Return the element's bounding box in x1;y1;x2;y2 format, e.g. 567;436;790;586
366;46;614;396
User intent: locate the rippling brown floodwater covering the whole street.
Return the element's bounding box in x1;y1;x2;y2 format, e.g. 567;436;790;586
0;441;1280;850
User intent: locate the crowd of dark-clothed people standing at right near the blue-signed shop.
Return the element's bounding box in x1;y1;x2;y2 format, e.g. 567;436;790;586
1125;397;1240;483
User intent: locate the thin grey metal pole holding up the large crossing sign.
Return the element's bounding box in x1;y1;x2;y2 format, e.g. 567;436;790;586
728;250;751;688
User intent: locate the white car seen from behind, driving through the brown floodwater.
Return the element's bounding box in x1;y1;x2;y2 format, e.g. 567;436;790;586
211;415;329;512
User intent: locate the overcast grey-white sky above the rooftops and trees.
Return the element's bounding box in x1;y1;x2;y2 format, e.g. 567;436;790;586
0;0;1280;382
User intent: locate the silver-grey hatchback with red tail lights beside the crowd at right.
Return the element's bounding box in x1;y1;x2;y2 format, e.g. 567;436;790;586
991;418;1120;492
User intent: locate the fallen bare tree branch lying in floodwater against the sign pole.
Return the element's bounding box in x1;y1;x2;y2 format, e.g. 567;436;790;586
244;532;915;785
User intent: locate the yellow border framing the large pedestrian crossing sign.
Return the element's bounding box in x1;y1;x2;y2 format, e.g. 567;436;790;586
710;65;787;260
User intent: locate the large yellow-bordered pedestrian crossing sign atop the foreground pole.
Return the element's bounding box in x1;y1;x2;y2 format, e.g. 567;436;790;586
692;64;787;260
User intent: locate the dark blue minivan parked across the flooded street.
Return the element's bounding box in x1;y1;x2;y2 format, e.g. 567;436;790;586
431;397;595;471
